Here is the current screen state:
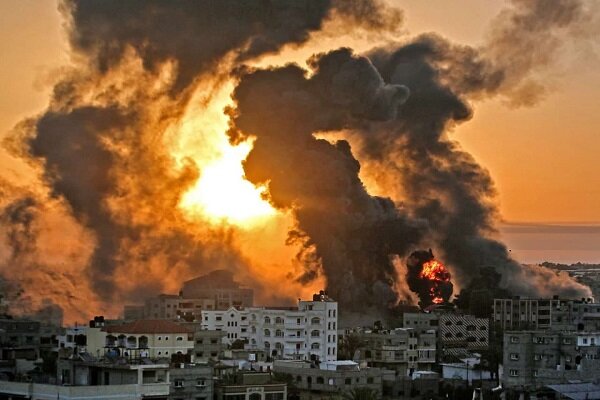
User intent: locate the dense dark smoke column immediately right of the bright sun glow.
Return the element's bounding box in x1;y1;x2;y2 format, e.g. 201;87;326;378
230;49;421;309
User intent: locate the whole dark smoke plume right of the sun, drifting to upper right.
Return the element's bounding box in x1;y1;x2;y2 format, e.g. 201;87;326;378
230;1;589;306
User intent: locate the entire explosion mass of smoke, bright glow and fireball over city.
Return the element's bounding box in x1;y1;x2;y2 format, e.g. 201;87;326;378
0;0;589;321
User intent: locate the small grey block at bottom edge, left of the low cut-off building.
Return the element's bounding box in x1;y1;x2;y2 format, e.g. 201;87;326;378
169;363;214;400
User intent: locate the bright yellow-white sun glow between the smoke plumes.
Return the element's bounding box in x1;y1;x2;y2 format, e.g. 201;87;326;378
168;80;277;228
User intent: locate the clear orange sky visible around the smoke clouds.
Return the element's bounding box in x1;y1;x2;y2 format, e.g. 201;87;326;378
0;0;600;222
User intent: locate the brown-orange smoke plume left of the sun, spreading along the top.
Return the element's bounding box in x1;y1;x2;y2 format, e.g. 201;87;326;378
3;0;404;320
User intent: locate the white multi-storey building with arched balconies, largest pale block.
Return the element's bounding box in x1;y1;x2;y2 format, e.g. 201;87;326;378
202;292;338;361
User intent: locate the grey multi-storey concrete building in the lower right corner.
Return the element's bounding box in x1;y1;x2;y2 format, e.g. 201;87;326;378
502;330;600;390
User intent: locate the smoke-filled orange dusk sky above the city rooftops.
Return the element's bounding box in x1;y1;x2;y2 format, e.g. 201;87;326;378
0;0;600;324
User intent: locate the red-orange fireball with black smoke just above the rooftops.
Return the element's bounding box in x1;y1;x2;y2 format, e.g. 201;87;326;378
406;249;454;308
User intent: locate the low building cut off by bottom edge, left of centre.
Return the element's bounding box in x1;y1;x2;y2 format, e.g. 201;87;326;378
215;372;287;400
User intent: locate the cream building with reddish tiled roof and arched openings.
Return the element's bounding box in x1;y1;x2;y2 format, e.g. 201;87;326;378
86;320;194;359
